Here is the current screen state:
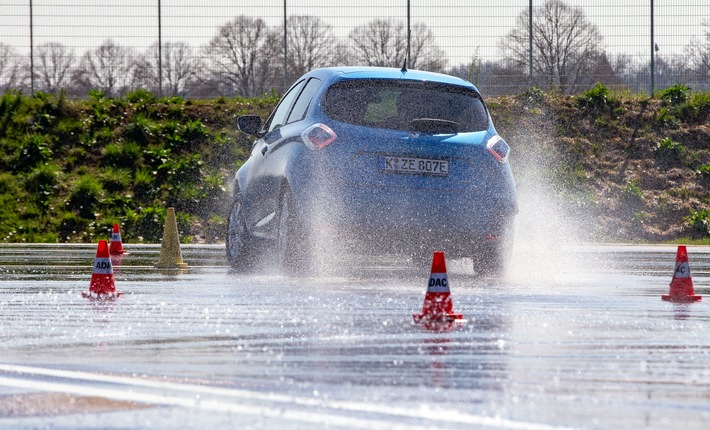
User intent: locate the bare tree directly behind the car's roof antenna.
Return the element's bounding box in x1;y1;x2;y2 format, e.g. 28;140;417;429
349;18;447;72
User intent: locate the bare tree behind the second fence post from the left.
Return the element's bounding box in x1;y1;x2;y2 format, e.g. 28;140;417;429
135;42;201;97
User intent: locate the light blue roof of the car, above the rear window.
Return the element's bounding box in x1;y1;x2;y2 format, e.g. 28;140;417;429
309;66;478;91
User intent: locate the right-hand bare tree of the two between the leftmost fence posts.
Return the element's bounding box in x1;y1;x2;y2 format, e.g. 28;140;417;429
72;39;136;97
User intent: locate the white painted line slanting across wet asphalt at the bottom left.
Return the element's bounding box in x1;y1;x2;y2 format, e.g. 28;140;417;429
0;364;567;430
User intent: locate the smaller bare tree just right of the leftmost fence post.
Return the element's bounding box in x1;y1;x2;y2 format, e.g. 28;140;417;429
34;42;75;93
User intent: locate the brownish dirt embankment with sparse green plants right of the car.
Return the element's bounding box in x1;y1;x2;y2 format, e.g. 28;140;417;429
488;86;710;241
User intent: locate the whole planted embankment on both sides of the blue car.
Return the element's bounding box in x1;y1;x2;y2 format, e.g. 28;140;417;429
0;84;710;244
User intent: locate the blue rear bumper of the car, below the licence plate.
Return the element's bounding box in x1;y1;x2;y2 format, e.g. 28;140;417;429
296;180;517;256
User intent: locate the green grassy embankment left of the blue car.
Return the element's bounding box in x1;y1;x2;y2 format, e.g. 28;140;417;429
0;91;277;242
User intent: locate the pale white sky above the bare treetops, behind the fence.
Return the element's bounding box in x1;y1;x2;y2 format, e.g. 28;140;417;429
0;0;710;65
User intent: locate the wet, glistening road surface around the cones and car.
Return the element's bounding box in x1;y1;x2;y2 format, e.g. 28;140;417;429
0;244;710;429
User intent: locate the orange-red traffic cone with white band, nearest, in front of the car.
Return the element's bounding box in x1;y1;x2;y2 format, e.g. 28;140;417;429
412;251;465;329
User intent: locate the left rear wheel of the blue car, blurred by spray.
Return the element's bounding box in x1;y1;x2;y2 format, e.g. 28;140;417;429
276;190;306;274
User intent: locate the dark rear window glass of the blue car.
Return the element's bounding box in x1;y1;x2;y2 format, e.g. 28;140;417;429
321;79;488;133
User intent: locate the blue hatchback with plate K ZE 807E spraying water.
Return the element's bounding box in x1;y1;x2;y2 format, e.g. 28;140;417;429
226;67;518;274
